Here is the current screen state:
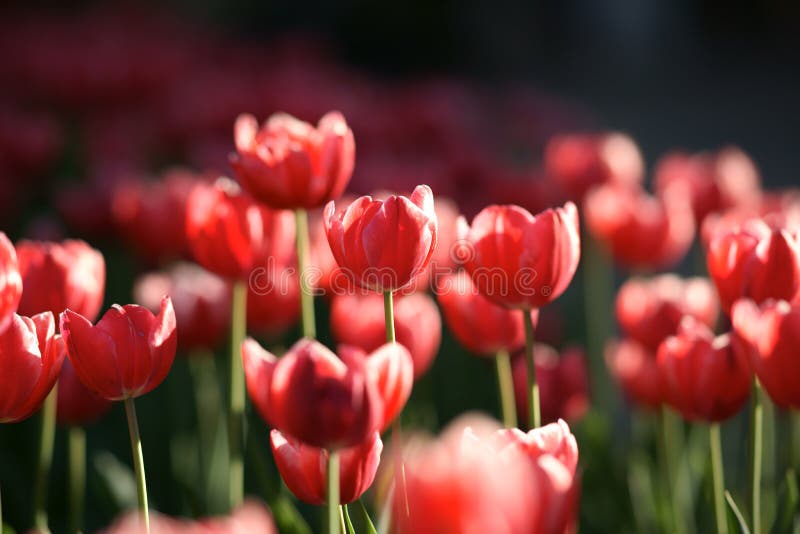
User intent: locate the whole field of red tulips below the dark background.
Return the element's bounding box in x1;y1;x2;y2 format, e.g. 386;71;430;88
0;5;800;534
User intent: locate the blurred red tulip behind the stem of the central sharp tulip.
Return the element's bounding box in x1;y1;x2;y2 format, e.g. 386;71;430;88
331;293;442;380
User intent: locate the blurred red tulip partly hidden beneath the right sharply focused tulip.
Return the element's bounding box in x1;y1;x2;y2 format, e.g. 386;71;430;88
436;271;539;356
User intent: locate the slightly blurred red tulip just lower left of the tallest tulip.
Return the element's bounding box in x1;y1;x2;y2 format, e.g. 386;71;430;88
186;178;294;280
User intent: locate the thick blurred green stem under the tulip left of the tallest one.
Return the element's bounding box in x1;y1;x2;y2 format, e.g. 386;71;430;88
228;281;247;509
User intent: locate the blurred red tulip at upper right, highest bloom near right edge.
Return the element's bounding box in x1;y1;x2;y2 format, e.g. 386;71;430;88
654;147;761;224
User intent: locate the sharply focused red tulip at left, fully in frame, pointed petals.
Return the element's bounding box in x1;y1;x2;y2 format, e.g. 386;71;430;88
61;297;177;400
